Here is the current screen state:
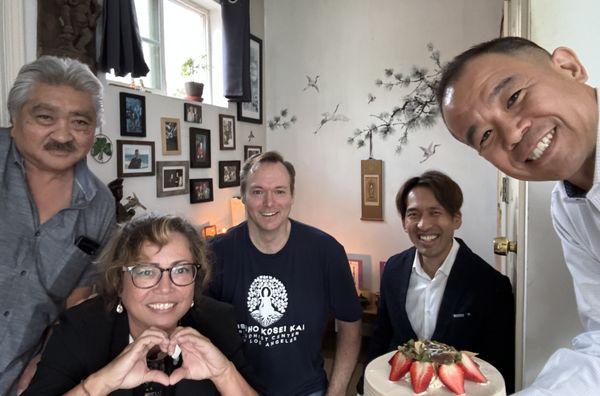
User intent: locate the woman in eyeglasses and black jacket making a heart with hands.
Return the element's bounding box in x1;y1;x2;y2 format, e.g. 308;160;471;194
25;214;256;396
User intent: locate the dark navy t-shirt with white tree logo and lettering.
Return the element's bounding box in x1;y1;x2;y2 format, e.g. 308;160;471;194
209;220;362;396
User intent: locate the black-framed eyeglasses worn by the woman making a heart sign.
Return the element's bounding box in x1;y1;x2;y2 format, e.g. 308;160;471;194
123;263;200;289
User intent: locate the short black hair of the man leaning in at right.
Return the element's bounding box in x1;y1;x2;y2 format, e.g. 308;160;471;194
436;37;551;116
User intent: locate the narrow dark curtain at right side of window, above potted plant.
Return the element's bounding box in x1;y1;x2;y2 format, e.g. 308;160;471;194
221;0;251;102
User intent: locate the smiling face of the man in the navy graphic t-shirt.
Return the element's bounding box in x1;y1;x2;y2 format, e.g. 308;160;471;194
243;162;294;236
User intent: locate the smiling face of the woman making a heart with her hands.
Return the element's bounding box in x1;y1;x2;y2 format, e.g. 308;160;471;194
120;232;194;338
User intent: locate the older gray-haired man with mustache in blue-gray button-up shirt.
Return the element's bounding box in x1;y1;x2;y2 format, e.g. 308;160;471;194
0;56;115;395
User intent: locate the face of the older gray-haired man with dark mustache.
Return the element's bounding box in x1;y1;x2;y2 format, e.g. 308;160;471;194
11;83;96;173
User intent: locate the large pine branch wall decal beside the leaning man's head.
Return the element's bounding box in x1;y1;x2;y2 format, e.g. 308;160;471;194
348;43;443;153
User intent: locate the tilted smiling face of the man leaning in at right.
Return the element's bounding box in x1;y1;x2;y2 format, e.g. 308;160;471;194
442;48;598;185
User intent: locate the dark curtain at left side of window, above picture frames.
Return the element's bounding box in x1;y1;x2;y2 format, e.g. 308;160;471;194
98;0;150;77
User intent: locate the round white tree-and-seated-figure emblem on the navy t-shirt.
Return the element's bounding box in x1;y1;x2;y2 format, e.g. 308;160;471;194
247;275;287;327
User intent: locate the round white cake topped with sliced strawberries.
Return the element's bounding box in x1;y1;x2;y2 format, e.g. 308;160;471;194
365;340;506;396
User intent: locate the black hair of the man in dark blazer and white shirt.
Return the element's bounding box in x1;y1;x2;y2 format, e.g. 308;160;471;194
396;171;463;221
